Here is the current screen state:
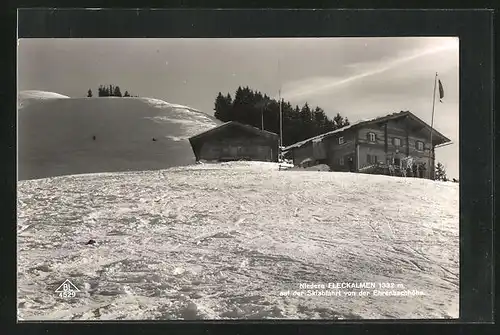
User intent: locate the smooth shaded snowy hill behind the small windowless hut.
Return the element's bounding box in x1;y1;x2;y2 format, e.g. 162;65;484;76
18;91;220;180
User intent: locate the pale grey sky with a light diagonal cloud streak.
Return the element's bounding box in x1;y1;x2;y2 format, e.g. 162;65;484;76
18;37;459;178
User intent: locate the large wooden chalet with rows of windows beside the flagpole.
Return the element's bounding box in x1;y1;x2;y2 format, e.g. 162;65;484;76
284;111;451;179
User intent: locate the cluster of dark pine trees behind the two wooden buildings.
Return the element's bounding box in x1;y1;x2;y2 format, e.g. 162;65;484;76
214;87;349;146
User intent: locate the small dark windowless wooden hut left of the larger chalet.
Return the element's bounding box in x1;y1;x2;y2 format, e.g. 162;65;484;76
189;121;279;162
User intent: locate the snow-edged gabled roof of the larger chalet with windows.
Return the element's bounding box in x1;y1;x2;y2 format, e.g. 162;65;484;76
283;111;451;151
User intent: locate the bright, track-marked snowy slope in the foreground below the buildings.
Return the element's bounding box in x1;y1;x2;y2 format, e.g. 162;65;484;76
18;163;459;320
